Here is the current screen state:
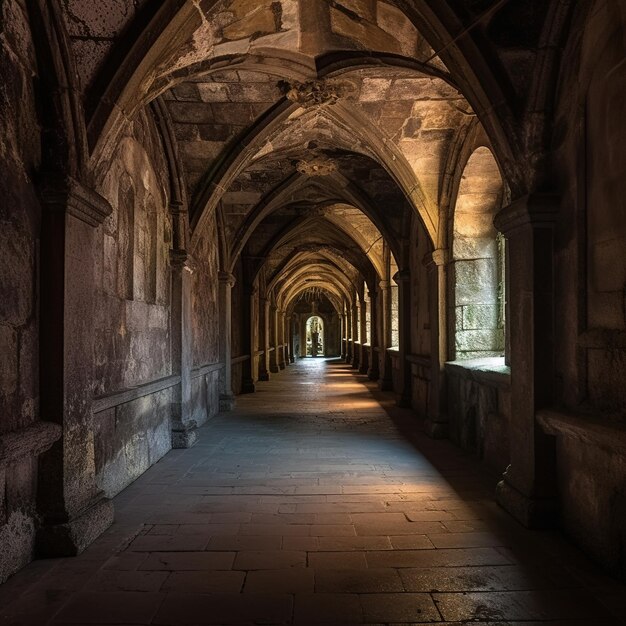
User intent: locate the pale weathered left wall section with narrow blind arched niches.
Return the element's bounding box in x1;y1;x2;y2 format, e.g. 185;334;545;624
94;111;173;496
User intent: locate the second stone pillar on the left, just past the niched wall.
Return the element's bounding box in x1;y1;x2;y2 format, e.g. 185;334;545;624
170;250;198;448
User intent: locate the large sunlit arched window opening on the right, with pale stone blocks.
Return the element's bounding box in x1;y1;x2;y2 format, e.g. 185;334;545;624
452;147;506;359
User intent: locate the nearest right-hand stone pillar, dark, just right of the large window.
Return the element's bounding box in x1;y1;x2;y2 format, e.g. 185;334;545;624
494;194;558;528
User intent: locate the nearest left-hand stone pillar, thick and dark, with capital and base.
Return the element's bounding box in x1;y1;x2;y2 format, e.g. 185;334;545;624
35;177;113;558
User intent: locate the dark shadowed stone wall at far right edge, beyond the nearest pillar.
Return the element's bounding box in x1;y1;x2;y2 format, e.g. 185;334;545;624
554;0;626;575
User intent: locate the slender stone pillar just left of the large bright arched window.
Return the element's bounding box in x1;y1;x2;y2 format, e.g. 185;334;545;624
424;248;450;439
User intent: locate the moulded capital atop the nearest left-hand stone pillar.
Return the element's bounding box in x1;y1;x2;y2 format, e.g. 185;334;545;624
39;174;113;227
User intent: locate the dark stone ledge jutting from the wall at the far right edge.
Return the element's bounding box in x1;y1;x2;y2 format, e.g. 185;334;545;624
537;409;626;454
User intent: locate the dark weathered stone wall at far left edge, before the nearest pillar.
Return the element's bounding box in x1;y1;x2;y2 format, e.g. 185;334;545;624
0;0;41;583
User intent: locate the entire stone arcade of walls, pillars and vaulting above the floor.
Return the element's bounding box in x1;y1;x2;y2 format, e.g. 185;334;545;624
0;0;626;608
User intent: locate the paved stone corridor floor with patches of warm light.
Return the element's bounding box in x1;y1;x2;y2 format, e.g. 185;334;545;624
0;359;626;626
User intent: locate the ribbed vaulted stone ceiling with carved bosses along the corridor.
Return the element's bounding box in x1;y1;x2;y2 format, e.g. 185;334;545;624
53;0;567;310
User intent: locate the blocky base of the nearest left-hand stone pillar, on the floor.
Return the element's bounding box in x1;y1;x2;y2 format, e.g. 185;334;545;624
35;497;114;559
